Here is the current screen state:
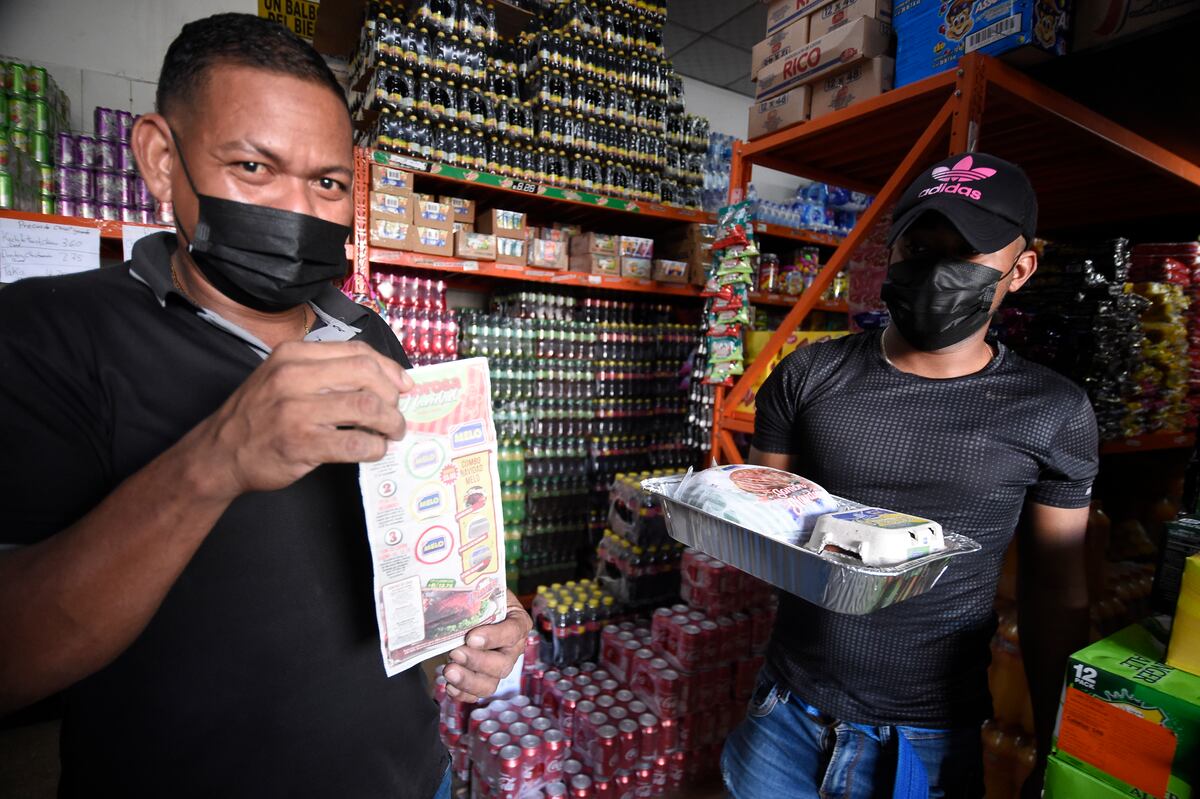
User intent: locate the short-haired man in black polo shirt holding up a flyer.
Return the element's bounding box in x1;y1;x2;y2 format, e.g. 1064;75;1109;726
0;14;530;799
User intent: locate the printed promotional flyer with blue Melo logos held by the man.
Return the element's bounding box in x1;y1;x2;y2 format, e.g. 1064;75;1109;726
359;358;508;677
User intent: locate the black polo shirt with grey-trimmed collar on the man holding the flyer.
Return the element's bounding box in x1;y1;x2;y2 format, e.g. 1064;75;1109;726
0;234;446;799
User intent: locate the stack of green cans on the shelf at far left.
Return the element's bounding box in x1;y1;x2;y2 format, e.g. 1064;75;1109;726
0;61;71;214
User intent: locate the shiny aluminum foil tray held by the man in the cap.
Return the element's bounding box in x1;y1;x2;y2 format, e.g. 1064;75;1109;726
642;475;982;615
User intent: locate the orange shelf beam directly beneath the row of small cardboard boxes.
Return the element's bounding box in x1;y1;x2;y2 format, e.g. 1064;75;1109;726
367;247;700;299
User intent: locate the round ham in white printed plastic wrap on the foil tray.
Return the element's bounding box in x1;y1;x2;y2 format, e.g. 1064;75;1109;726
673;464;838;543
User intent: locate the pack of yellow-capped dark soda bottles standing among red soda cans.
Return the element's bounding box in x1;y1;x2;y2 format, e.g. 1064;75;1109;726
533;579;617;667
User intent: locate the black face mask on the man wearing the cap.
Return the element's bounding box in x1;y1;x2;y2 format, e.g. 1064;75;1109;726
882;258;1016;353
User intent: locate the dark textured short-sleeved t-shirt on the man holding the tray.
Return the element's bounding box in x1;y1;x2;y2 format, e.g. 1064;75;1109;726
754;331;1098;728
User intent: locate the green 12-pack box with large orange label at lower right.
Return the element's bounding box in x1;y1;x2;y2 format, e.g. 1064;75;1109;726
1054;620;1200;799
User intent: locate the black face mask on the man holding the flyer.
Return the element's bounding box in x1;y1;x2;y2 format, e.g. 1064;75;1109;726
172;132;350;313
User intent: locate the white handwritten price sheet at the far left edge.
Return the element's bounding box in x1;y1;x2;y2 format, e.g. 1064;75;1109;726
0;220;100;283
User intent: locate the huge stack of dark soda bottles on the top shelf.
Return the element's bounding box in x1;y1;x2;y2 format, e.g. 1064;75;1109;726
349;0;708;208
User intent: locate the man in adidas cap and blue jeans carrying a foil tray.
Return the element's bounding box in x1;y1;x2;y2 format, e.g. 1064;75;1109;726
722;154;1097;799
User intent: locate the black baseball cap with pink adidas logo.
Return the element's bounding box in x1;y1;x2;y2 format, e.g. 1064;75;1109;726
888;152;1038;252
